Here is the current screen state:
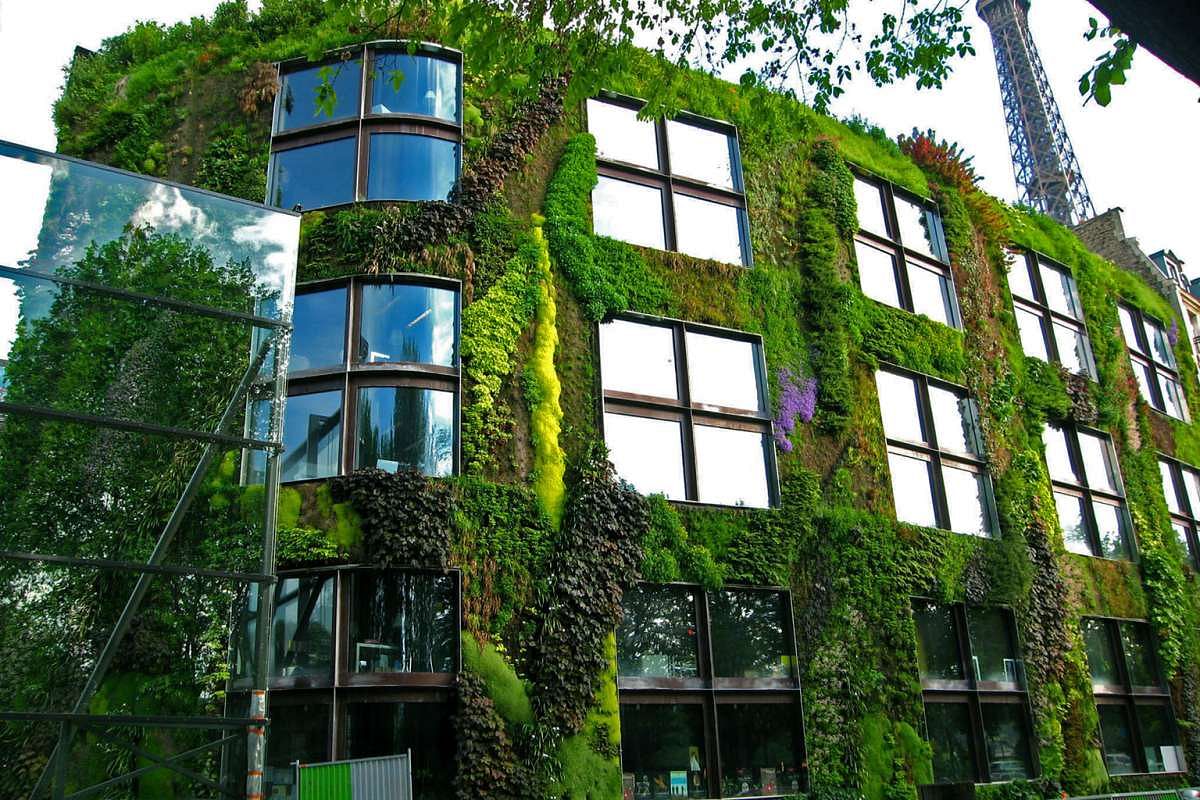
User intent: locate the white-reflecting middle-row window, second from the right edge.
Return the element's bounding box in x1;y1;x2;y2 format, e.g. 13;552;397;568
1042;423;1134;560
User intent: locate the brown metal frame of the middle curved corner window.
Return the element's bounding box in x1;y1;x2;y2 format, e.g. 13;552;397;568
286;272;462;483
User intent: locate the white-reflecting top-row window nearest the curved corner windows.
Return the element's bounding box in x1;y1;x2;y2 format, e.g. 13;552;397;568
587;97;751;265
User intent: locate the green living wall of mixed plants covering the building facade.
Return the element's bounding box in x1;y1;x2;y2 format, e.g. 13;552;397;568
7;0;1200;800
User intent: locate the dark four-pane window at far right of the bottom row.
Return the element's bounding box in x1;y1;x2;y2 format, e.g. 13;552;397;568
1082;618;1187;776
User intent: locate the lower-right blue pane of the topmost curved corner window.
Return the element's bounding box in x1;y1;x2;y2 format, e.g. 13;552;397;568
367;133;458;200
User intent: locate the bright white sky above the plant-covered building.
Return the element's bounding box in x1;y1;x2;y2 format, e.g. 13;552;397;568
0;0;1200;276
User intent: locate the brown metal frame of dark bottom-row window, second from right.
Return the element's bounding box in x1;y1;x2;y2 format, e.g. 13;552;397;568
910;596;1042;783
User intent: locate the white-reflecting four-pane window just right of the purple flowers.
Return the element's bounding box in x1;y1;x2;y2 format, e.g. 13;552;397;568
875;367;998;536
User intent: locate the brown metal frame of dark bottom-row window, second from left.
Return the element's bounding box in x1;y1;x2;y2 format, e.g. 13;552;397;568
617;582;808;798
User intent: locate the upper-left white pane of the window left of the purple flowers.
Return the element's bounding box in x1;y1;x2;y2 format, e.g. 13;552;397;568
600;319;679;399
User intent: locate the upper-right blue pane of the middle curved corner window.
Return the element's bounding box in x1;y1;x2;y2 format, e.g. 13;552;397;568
359;283;458;367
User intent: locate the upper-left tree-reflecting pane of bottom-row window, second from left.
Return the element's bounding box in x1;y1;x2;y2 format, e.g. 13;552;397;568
617;584;700;678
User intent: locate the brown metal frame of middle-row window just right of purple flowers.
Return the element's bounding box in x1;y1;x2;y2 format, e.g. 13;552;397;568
876;362;1000;539
